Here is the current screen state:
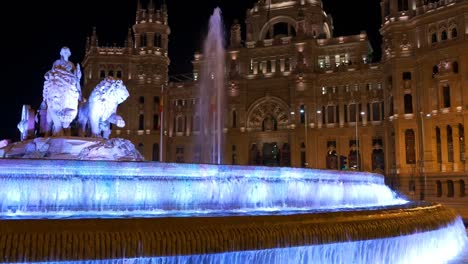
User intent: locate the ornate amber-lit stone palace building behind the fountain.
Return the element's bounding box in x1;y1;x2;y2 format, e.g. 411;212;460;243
83;0;468;217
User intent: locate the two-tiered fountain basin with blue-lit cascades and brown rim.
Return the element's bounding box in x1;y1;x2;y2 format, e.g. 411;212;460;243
0;7;467;264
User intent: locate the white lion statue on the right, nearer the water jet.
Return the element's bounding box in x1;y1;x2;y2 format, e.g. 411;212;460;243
78;77;129;139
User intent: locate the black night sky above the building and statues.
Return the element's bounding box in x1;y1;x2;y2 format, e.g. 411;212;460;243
0;0;381;141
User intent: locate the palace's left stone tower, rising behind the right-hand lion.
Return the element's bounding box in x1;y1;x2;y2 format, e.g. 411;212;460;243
83;0;170;160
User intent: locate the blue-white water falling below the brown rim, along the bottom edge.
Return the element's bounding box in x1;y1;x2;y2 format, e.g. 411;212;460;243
32;221;468;264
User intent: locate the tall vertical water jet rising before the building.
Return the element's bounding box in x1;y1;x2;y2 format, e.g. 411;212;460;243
194;8;226;164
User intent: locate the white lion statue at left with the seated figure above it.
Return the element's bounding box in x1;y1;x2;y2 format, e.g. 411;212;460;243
42;47;81;136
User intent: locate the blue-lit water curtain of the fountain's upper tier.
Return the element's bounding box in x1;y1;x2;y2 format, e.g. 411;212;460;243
0;159;407;218
